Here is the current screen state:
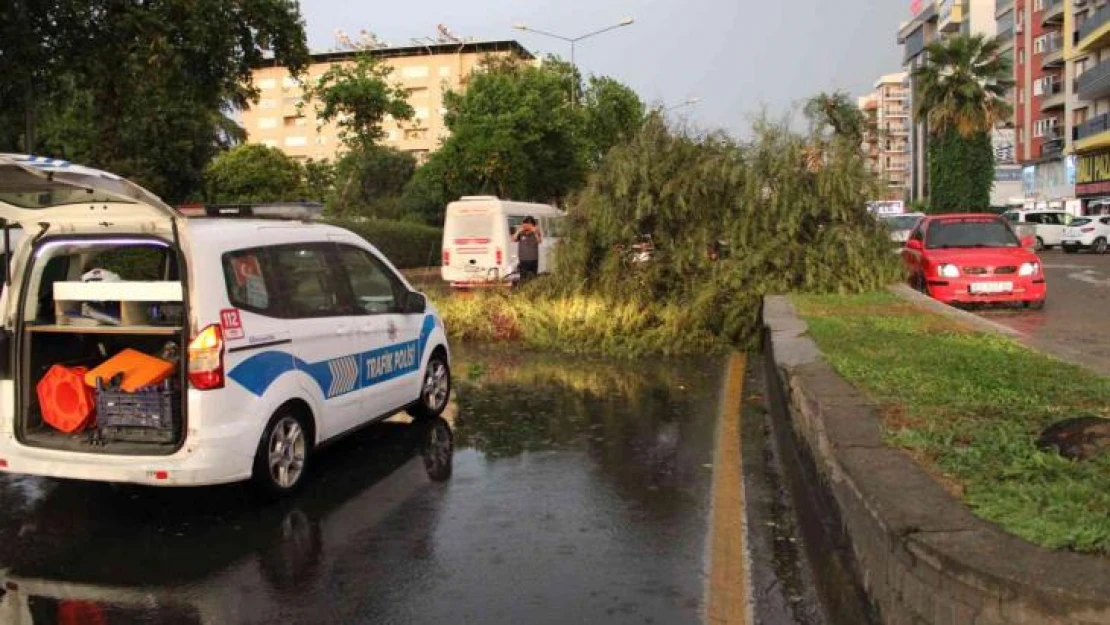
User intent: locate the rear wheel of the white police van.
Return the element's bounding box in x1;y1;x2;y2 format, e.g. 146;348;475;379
252;407;312;497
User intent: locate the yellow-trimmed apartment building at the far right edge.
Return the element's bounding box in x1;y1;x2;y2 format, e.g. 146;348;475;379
1063;0;1110;214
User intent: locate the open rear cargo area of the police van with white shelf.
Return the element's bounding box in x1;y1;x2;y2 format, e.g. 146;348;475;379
13;236;188;455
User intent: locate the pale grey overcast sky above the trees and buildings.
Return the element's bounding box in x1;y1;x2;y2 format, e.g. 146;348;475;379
301;0;909;134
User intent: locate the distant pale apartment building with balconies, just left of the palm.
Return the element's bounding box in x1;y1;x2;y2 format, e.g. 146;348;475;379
858;72;910;200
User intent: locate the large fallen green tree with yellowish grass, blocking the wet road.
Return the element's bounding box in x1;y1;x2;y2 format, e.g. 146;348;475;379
447;117;899;354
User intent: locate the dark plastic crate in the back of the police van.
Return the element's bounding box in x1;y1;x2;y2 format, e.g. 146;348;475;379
97;381;181;443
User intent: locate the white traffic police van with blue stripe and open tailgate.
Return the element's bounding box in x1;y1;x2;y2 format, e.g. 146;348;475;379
0;154;451;493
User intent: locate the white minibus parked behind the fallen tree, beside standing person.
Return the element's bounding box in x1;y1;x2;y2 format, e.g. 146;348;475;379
441;195;565;286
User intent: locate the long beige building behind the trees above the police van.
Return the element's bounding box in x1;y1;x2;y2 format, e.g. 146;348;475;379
241;41;533;162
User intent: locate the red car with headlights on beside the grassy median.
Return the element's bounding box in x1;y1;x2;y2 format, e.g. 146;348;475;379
902;213;1047;309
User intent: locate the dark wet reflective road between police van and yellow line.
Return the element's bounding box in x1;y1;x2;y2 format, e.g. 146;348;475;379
0;346;723;624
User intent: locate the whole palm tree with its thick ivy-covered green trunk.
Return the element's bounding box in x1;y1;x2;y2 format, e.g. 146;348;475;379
914;34;1013;212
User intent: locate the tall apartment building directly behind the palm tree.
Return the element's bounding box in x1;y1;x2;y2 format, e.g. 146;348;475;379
898;0;1032;205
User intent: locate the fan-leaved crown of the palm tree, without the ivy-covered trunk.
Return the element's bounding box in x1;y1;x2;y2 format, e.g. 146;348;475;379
914;34;1013;137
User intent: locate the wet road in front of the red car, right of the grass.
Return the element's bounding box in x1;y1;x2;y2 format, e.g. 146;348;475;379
978;251;1110;375
